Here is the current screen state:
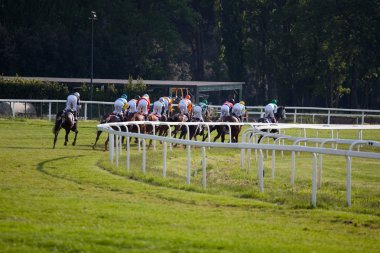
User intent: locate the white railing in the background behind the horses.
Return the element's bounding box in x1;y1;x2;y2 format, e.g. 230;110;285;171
0;99;380;124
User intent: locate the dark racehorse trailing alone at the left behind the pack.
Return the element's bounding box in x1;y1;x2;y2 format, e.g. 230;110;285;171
53;110;78;149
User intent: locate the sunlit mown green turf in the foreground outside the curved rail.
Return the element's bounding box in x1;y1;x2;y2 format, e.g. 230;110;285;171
0;119;380;252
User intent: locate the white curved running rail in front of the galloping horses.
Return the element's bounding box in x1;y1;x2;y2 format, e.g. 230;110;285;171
97;122;380;207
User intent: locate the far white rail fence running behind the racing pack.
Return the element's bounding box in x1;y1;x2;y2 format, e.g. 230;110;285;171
0;99;380;124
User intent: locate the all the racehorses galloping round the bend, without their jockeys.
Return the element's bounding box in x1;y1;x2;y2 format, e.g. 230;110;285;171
53;102;286;150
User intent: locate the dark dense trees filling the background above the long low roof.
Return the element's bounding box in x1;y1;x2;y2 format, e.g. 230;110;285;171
0;0;380;109
